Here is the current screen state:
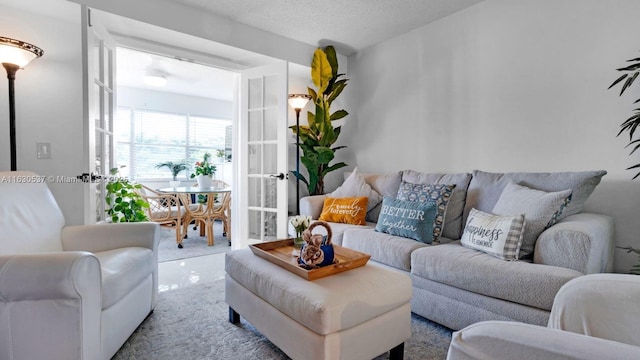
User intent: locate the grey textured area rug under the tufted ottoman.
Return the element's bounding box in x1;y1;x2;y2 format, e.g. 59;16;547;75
112;280;451;360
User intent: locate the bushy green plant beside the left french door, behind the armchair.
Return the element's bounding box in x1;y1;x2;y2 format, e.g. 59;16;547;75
105;166;149;223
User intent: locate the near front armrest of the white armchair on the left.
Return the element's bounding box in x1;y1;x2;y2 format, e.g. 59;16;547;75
0;251;102;359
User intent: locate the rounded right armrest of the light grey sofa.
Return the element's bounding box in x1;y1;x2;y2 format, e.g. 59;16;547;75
533;213;615;274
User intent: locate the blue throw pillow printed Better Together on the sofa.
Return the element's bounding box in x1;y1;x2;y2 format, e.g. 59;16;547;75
376;196;436;244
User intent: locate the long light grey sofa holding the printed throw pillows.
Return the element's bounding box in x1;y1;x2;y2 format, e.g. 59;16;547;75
300;170;614;330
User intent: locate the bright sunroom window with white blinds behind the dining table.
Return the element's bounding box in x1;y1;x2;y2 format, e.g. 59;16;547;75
114;107;231;180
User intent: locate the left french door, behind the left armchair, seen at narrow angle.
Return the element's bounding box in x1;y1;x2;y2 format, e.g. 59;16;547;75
81;5;116;224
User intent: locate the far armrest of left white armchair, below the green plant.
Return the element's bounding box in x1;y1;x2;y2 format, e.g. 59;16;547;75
61;222;160;254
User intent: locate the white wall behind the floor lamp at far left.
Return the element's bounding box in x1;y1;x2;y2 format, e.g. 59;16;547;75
0;3;84;224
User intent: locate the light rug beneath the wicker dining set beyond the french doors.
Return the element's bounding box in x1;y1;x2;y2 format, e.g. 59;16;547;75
158;221;231;262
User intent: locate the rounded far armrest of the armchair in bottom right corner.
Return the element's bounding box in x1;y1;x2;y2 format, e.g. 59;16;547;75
548;274;640;348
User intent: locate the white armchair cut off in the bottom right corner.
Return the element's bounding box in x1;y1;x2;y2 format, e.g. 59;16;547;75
447;274;640;360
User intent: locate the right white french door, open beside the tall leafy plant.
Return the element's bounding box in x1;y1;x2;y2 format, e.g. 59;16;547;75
232;61;288;248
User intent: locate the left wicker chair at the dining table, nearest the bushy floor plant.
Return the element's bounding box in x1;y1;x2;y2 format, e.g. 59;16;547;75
138;185;193;248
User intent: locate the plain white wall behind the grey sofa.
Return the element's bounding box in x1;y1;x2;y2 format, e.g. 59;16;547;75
343;0;640;272
